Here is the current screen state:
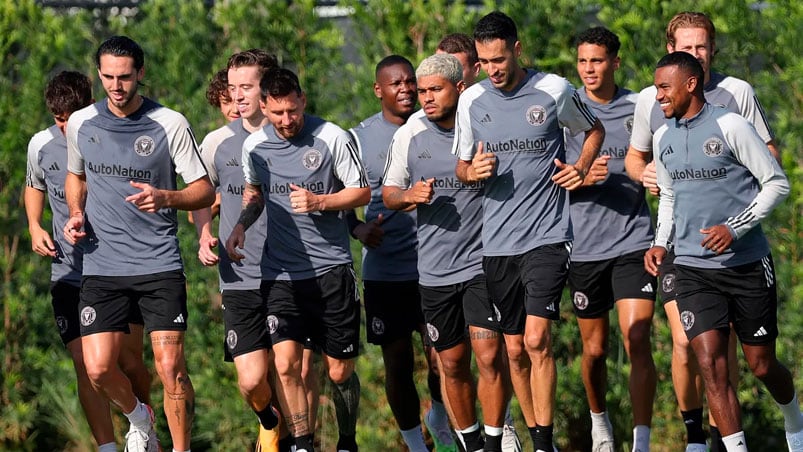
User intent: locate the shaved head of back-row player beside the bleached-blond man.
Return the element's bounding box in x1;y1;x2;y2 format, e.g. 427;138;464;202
374;63;416;124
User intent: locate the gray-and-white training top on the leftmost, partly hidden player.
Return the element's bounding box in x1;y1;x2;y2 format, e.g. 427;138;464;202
25;125;83;286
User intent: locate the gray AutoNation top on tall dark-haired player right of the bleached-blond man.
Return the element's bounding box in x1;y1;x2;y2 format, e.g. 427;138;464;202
452;70;596;256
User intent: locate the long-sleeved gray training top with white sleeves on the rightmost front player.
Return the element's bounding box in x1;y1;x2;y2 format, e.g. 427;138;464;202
653;104;789;268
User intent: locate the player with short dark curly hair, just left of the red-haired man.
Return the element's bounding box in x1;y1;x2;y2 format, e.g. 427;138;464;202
566;27;657;452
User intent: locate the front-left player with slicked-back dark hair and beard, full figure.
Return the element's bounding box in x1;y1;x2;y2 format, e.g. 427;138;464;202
63;36;215;451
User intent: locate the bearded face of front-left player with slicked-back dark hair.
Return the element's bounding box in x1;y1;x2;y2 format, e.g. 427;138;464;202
98;54;145;117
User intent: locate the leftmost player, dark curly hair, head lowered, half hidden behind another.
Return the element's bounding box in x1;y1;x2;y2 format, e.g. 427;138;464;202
24;71;151;452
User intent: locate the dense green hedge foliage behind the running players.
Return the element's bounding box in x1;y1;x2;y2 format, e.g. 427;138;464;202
0;0;803;451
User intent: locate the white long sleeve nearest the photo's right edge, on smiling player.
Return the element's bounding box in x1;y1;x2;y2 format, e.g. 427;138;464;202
719;113;789;239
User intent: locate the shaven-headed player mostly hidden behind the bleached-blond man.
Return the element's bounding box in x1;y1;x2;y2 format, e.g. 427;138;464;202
348;55;457;452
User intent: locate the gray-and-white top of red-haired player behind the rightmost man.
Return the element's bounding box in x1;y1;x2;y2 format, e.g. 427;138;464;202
630;72;773;152
